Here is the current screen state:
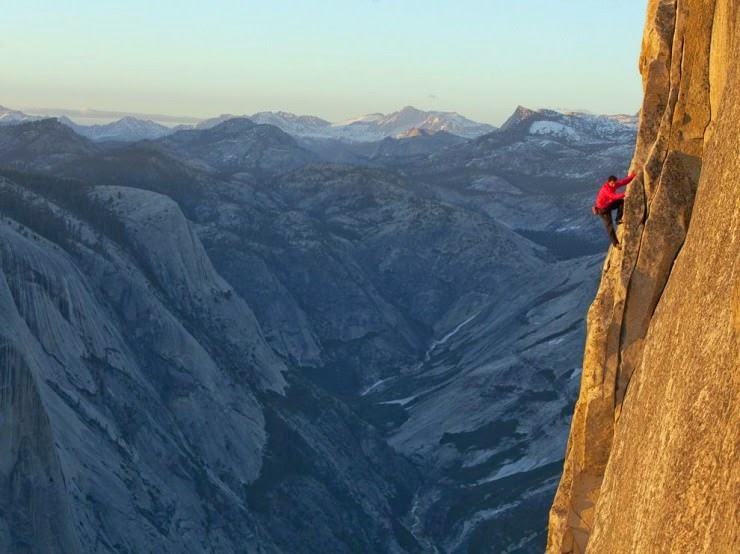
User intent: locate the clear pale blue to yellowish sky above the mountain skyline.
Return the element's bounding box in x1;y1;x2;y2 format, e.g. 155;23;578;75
0;0;647;124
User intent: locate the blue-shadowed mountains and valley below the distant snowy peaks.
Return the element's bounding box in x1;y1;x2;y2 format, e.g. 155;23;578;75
0;102;634;553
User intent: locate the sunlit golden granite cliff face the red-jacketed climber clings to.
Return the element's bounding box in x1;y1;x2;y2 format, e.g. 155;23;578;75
548;0;740;553
